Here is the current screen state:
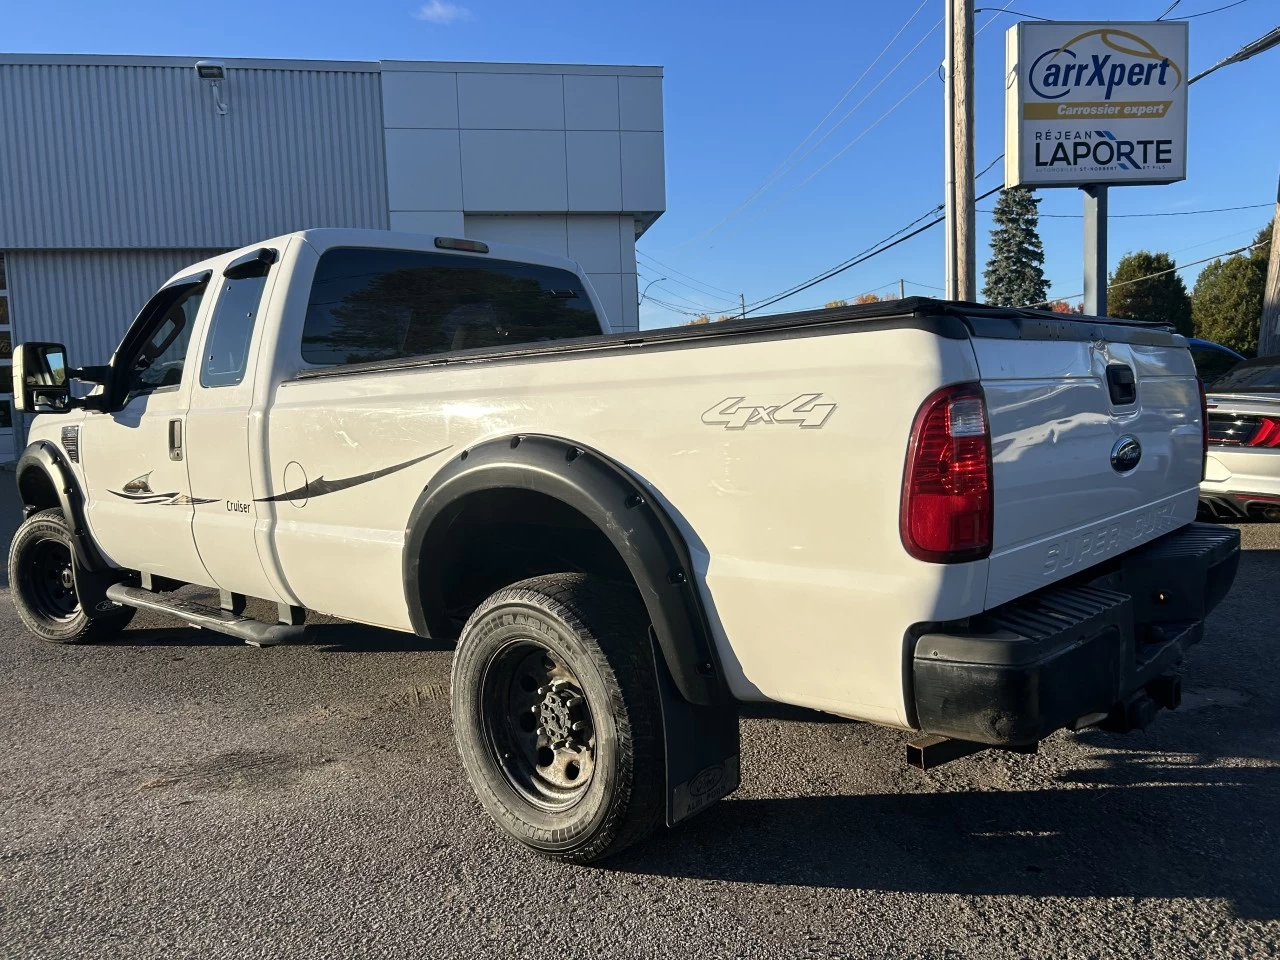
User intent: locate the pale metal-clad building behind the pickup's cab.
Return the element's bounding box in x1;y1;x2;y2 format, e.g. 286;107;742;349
0;55;666;460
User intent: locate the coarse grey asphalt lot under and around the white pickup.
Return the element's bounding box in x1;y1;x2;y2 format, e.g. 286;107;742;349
0;496;1280;959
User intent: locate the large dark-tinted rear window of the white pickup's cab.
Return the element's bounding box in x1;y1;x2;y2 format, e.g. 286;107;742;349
302;247;600;364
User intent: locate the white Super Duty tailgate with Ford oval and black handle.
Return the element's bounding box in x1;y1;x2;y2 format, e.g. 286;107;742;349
972;337;1202;609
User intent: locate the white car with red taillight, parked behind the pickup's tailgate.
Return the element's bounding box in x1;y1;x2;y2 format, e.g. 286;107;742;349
1201;357;1280;520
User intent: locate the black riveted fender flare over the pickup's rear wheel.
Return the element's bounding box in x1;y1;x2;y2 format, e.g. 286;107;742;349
403;434;731;705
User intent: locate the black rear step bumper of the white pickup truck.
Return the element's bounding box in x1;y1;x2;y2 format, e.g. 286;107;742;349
911;524;1240;746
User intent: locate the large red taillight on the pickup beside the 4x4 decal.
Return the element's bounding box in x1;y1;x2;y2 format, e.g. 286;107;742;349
899;383;995;563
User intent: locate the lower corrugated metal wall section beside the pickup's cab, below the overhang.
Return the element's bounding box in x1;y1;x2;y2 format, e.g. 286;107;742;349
5;250;216;366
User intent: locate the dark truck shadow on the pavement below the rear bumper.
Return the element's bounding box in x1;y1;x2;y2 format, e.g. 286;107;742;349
609;758;1280;920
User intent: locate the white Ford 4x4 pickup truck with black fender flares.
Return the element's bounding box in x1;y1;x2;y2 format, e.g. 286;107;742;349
9;229;1239;861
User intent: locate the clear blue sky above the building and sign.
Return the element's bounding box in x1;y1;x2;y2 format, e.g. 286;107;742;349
3;0;1280;326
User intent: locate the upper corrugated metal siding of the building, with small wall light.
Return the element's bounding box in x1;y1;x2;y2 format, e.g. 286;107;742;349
0;64;388;251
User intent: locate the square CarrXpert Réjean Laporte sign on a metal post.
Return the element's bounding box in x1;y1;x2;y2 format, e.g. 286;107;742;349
1005;22;1188;187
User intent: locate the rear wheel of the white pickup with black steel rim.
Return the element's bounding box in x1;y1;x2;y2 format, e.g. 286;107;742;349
452;573;666;864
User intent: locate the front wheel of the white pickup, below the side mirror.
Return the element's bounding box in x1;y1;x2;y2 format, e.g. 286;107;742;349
9;508;133;644
